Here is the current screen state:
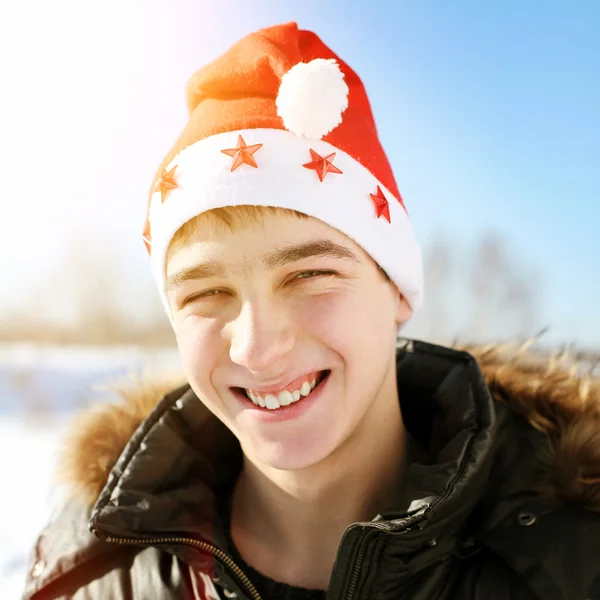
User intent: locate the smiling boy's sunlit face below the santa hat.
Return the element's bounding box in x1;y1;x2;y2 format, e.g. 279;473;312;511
166;215;411;469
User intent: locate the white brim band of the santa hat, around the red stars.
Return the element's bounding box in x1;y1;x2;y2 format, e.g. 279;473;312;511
149;129;423;312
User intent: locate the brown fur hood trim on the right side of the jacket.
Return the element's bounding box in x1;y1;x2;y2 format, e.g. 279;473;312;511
463;341;600;511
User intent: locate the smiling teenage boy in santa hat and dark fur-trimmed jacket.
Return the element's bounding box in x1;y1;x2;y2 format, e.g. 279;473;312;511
25;23;600;600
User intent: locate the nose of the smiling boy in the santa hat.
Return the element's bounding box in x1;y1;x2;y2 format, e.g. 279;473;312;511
229;302;295;372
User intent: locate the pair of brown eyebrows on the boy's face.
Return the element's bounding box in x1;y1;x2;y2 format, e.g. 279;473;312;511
164;240;361;292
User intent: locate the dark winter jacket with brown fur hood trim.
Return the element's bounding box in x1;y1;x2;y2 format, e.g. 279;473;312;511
25;341;600;600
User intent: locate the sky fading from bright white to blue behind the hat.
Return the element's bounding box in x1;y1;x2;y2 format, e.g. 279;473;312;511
0;0;600;346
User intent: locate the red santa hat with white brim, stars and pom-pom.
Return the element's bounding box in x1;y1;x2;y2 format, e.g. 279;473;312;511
144;23;423;309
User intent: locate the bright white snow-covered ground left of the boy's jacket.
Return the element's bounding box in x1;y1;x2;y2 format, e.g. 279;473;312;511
0;345;178;600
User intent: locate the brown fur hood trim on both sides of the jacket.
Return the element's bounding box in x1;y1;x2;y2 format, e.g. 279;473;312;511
57;343;600;511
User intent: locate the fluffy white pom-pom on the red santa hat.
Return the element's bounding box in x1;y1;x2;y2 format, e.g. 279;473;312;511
276;58;348;140
